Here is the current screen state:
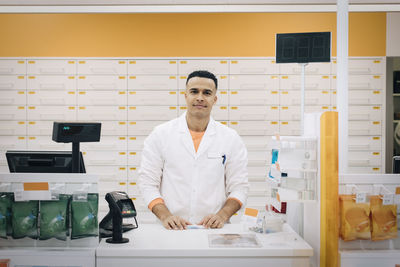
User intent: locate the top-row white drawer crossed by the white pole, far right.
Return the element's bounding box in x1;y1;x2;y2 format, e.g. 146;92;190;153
332;58;386;74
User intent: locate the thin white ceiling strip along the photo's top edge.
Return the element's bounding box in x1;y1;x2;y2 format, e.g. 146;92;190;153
0;0;400;6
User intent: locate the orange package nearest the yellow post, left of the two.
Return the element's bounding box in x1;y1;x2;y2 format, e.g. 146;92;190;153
339;195;371;241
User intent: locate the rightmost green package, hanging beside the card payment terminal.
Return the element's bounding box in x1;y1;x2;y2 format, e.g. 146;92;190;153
71;194;99;239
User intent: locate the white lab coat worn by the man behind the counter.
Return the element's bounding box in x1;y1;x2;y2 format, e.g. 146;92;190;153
139;113;249;223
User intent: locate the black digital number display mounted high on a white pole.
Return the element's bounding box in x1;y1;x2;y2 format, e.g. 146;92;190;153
276;32;331;63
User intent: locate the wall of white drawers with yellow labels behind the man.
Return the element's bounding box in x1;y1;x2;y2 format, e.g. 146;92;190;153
0;58;385;222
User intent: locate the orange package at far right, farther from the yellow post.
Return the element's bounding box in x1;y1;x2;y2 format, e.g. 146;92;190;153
370;196;397;241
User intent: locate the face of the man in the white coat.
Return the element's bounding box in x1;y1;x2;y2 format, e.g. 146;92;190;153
185;77;217;119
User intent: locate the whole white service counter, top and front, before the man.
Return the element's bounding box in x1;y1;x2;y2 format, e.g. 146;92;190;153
96;224;313;267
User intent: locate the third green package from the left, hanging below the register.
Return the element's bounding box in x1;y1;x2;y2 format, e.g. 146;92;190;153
39;195;71;240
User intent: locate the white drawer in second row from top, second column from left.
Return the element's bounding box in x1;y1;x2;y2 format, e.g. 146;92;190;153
26;75;76;91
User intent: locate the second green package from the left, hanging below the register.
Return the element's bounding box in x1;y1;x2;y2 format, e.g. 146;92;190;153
11;200;39;239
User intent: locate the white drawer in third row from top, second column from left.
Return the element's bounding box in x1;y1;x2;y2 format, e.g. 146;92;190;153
27;91;76;106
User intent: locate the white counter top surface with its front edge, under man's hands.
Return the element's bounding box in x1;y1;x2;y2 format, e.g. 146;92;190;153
96;224;313;258
